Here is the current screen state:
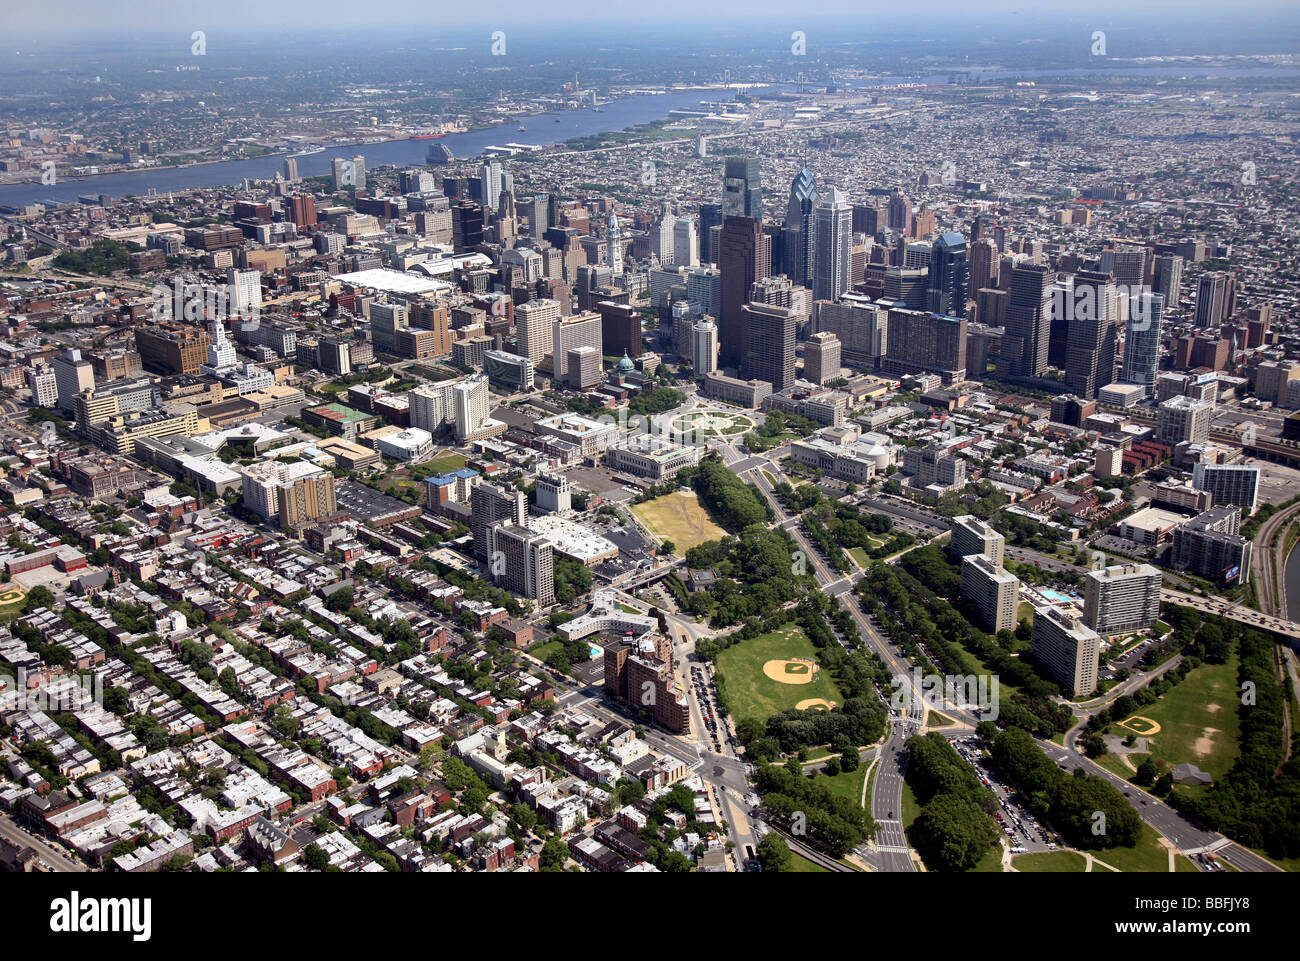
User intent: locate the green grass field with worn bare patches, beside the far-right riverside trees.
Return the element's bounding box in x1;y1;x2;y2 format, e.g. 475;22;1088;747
1110;654;1240;779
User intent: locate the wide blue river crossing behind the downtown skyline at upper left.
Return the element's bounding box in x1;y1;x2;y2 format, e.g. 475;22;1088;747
0;90;722;207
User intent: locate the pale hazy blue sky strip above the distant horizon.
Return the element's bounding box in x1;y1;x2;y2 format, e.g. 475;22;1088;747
10;0;1297;33
